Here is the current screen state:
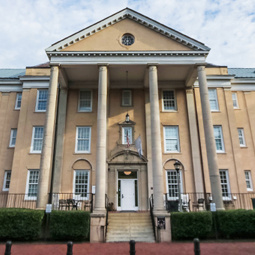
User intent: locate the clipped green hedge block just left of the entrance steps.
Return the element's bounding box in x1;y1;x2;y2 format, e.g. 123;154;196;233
50;211;90;241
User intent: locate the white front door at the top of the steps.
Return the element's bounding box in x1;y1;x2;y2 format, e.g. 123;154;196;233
121;179;137;211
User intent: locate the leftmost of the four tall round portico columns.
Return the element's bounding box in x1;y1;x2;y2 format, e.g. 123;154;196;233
36;66;59;208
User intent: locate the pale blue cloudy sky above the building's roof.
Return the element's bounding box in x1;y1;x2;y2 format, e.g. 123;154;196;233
0;0;255;68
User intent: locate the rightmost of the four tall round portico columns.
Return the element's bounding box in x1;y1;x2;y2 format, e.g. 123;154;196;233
197;66;224;210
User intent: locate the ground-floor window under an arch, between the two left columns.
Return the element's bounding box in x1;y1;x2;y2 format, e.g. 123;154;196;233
73;170;89;200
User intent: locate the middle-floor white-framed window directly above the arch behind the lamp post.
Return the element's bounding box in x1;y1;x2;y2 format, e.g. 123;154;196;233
164;126;180;152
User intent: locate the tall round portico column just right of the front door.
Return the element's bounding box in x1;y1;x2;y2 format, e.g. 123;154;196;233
149;66;164;211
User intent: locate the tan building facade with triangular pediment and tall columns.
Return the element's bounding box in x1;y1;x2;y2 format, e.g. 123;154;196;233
0;8;255;241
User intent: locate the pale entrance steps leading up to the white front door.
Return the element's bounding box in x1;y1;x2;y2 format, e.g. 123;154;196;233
106;212;155;243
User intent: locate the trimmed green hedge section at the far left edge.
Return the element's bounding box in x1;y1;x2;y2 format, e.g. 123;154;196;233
0;208;44;240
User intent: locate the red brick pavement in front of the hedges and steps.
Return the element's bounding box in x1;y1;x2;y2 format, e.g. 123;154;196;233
0;241;255;255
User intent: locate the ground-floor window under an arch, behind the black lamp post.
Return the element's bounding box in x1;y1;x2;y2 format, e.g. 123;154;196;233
166;170;182;200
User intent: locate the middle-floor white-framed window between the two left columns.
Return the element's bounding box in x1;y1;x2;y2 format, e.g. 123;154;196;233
75;127;91;153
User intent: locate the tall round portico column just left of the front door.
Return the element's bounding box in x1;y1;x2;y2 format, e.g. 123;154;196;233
94;66;107;212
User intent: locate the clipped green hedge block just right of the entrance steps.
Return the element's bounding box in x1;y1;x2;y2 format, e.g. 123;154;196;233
171;212;212;240
